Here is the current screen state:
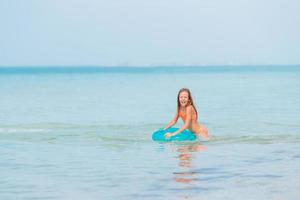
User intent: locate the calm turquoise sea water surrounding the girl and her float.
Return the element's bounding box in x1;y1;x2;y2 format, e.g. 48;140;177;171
0;66;300;200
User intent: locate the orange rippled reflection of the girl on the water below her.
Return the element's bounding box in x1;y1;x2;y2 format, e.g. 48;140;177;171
173;142;207;199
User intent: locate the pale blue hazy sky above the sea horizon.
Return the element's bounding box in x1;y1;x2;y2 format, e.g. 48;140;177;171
0;0;300;66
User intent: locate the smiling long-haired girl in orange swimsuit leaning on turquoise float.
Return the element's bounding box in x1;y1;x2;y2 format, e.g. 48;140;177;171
164;88;208;139
